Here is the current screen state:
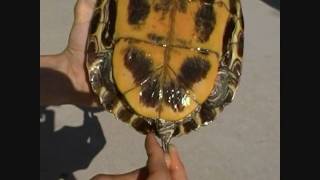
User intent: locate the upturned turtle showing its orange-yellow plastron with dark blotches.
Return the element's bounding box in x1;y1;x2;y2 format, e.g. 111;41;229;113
86;0;244;151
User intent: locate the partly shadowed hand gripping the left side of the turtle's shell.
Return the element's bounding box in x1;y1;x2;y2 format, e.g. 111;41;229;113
40;0;99;107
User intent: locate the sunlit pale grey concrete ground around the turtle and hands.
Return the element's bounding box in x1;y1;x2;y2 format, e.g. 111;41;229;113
40;0;280;180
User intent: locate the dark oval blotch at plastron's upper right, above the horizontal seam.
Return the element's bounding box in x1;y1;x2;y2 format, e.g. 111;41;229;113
195;4;216;43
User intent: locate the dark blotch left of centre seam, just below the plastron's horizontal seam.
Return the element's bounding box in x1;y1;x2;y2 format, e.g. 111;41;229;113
124;47;152;84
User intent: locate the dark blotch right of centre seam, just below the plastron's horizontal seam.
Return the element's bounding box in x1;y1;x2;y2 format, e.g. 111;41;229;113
178;56;211;88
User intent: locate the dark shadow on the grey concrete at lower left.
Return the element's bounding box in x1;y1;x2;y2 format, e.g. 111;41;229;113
40;107;106;180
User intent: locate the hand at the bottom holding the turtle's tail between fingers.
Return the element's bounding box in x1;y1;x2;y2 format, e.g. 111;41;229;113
91;134;187;180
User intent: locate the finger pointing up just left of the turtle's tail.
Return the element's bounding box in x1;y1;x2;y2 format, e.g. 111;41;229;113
145;133;169;176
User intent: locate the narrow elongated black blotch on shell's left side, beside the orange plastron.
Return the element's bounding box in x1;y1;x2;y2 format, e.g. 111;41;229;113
101;0;117;47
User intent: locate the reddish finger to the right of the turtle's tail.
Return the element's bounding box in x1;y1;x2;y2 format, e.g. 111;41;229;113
169;145;188;180
